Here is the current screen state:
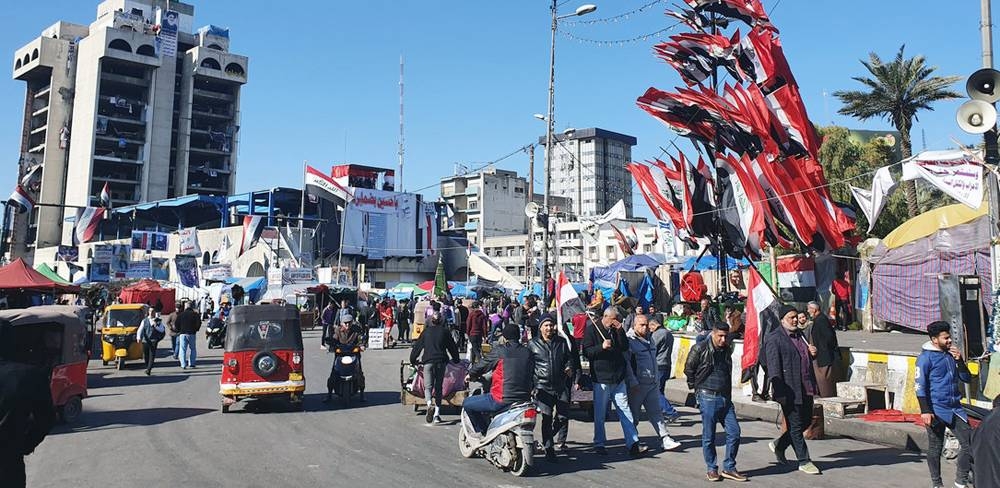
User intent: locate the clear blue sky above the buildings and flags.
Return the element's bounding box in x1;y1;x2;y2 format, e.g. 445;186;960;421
0;0;981;219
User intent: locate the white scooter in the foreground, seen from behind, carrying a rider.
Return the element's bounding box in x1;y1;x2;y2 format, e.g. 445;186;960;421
458;402;538;476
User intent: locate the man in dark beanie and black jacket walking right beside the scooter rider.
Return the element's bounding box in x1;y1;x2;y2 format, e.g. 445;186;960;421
528;314;573;462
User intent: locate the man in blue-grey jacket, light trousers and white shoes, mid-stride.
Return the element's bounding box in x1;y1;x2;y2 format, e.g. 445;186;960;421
625;314;680;451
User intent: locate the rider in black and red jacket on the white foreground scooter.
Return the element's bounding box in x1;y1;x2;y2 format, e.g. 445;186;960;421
462;324;535;435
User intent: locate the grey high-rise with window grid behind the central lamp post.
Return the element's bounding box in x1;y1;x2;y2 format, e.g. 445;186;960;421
538;127;636;217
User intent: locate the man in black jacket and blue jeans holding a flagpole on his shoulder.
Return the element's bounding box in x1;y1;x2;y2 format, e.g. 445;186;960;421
583;306;639;457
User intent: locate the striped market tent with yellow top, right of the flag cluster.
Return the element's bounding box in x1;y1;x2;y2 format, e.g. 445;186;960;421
869;204;993;331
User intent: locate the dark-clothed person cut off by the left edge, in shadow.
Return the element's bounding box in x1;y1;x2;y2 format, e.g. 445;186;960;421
0;323;55;487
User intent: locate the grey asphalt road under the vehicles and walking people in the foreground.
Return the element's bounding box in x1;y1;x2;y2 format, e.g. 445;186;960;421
27;331;954;488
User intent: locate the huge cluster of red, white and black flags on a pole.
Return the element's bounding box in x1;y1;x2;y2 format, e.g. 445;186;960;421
627;0;854;258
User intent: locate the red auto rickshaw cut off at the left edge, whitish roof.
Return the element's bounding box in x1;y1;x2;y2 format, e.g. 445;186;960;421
0;305;87;423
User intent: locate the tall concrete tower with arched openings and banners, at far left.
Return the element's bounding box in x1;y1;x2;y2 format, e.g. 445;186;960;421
10;0;248;259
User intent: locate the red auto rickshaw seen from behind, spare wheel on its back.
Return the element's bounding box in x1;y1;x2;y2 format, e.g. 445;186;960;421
219;304;306;413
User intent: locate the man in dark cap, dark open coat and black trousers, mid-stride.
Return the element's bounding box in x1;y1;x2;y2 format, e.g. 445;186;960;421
763;305;820;474
